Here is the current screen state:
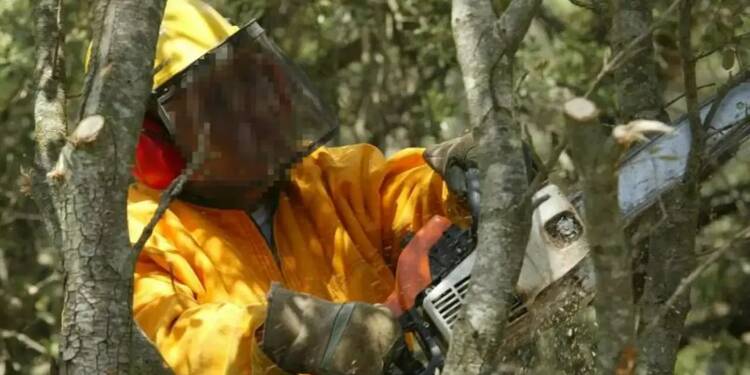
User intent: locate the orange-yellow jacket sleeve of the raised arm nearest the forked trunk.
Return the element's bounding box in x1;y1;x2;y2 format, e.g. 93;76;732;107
282;144;465;284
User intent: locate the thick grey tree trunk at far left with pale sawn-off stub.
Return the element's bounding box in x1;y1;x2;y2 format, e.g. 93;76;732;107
34;0;170;374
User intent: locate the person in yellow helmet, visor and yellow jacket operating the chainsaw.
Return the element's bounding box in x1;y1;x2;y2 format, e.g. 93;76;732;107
128;0;476;374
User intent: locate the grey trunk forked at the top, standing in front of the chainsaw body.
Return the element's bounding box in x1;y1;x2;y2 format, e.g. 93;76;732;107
444;0;541;374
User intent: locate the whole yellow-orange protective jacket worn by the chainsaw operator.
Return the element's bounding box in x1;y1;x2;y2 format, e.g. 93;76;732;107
128;145;464;374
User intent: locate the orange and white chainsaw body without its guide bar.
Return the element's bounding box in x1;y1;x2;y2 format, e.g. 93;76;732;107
392;185;588;375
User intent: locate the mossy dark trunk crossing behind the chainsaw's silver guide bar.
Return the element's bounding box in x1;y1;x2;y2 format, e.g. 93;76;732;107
610;0;695;374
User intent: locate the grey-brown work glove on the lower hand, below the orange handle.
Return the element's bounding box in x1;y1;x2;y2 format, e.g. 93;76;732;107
261;284;402;375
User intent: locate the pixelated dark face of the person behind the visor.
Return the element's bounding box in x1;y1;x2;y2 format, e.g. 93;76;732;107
165;49;298;208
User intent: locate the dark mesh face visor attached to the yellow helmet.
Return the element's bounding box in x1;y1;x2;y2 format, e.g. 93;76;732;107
156;21;337;191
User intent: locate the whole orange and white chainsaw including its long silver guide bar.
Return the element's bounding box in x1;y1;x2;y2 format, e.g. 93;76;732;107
385;81;750;375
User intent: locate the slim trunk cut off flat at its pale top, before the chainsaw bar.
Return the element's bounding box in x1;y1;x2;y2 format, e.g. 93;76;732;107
564;98;635;374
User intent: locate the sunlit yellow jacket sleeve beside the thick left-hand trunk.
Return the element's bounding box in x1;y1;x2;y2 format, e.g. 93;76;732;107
128;187;281;374
